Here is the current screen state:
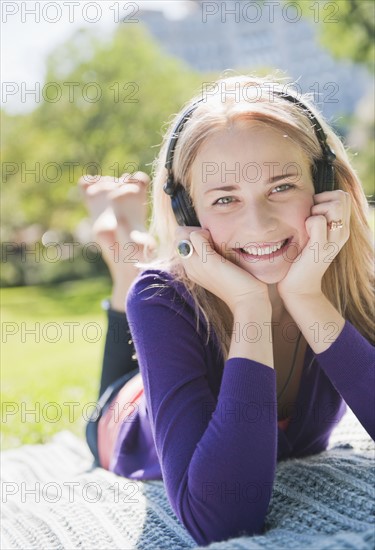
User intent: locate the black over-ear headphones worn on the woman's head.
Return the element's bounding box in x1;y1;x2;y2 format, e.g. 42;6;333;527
163;91;336;227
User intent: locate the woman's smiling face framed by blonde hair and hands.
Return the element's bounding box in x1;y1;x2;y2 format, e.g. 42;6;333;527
191;123;315;284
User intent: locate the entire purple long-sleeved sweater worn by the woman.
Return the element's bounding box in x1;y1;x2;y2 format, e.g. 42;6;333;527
111;270;375;544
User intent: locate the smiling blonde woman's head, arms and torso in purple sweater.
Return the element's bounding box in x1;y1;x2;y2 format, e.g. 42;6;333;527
88;77;375;544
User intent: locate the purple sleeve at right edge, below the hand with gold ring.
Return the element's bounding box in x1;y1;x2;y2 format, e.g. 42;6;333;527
316;321;375;440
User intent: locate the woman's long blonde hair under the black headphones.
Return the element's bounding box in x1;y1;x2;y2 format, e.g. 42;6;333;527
147;76;374;359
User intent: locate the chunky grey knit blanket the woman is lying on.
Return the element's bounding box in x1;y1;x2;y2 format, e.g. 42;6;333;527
1;410;375;550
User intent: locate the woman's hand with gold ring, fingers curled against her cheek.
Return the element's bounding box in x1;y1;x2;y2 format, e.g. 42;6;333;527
277;190;351;302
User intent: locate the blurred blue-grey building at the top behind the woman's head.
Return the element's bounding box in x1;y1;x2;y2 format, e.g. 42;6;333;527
140;0;372;127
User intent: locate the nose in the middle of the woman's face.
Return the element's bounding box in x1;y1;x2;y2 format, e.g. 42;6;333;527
241;200;278;242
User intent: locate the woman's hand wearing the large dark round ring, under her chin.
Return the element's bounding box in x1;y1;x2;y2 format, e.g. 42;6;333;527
176;226;270;313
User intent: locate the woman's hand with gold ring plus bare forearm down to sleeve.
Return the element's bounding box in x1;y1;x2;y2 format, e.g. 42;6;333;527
277;190;350;353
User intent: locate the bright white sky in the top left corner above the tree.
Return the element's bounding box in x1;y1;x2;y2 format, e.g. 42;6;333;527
0;0;194;114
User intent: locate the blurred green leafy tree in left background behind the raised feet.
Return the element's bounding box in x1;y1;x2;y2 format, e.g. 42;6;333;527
1;24;201;238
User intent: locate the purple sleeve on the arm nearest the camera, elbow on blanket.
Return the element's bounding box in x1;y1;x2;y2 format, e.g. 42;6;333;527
127;277;277;545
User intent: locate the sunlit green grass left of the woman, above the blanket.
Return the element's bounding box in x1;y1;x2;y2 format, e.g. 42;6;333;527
1;279;110;449
